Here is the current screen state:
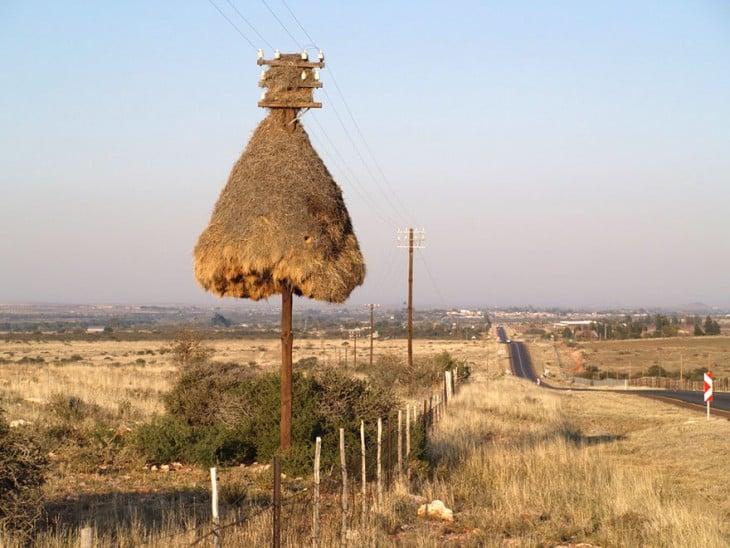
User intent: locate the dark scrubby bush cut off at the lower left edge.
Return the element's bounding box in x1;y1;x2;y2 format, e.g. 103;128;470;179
0;408;46;543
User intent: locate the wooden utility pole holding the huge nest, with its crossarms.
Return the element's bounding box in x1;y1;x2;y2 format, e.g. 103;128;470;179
257;50;324;453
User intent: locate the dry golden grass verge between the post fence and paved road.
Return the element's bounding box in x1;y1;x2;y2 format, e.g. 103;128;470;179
416;362;730;546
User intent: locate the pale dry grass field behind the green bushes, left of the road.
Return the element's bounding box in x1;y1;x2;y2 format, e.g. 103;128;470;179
0;339;490;422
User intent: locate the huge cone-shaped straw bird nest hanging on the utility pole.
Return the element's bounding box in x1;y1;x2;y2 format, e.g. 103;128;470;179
194;109;365;303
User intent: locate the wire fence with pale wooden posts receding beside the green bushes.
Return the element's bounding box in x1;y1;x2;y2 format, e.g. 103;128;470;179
69;370;464;548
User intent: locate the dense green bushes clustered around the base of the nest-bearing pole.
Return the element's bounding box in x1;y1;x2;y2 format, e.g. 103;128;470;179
139;363;398;474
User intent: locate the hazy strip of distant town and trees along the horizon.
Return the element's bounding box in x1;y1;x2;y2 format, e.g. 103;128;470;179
0;303;730;339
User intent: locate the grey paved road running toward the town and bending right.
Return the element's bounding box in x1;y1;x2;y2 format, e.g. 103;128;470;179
497;327;730;419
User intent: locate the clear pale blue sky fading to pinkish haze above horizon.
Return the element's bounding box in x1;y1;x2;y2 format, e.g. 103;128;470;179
0;0;730;308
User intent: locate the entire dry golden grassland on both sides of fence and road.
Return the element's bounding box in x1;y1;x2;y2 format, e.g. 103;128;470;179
0;338;730;546
